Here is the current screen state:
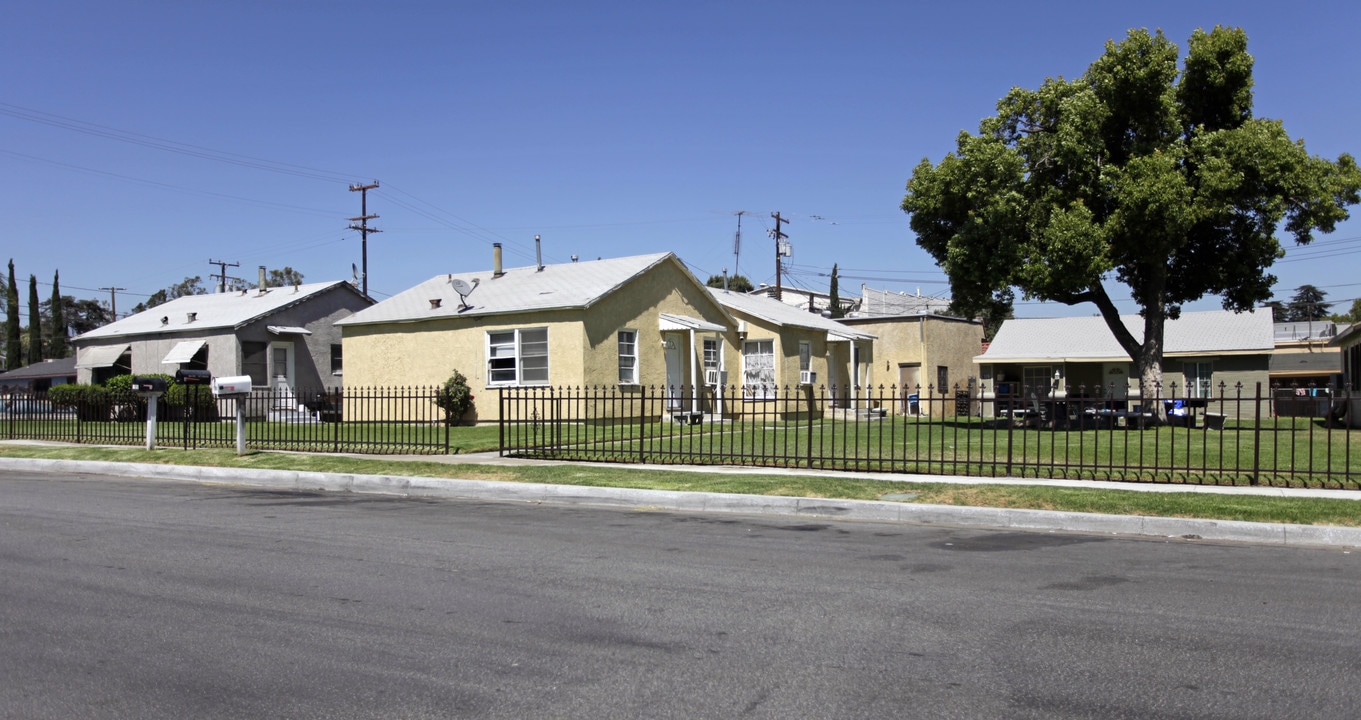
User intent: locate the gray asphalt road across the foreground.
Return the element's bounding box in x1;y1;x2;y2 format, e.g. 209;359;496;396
0;471;1361;720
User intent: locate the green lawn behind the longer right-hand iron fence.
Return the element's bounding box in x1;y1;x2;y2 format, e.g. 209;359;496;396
508;418;1361;487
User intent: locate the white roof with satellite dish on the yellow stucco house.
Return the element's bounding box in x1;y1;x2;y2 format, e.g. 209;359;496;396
336;253;713;325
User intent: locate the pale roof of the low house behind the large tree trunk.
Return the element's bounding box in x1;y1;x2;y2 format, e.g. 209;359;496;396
974;310;1275;362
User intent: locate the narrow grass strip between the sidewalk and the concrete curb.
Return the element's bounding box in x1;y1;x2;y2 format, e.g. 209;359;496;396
0;444;1361;527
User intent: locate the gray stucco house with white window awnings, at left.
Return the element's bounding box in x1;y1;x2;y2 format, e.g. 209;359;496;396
71;280;373;392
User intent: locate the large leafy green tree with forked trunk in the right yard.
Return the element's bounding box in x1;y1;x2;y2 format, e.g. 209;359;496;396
902;27;1361;392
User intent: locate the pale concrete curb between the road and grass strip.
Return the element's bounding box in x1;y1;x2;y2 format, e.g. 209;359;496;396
0;457;1361;547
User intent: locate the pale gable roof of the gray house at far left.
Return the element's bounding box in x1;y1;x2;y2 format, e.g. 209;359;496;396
76;280;359;342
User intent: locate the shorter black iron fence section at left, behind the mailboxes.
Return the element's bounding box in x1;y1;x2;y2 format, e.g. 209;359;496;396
0;387;449;455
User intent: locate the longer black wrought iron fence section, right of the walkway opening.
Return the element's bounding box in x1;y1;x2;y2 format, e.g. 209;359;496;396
499;384;1361;489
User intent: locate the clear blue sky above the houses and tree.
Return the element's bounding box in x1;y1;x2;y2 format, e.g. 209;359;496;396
0;0;1361;316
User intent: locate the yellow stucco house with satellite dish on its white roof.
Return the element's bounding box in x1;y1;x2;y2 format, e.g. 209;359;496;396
338;250;738;422
